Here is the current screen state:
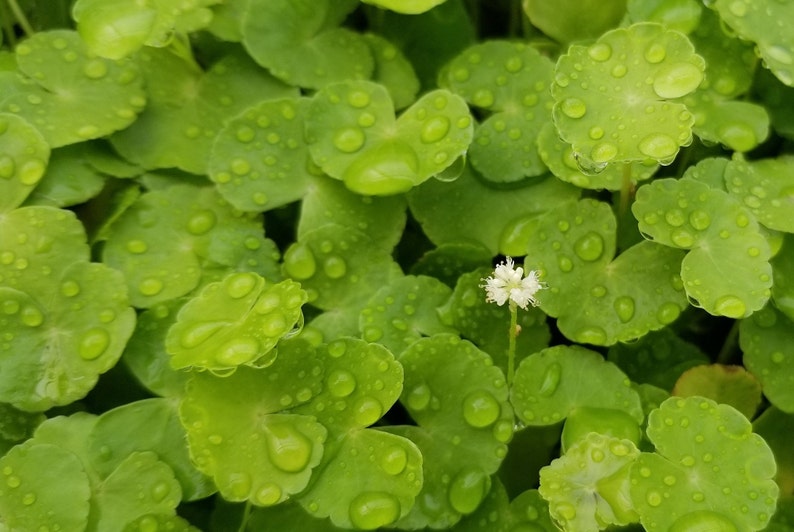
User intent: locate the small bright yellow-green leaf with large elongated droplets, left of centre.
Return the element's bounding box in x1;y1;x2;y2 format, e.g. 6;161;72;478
165;273;306;372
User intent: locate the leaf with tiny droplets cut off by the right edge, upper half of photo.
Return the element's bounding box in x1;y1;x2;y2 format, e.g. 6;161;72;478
725;155;794;233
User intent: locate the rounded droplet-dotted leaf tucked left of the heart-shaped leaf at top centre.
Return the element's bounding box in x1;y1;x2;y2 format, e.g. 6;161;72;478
208;98;316;212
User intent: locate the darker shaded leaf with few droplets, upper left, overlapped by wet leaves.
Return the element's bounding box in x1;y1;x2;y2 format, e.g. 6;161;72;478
110;49;296;174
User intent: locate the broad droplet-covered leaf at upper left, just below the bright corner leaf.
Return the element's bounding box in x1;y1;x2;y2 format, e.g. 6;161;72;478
0;30;146;148
